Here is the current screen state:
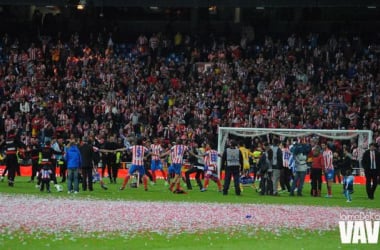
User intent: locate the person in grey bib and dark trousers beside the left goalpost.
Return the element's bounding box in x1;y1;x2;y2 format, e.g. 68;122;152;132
222;140;243;195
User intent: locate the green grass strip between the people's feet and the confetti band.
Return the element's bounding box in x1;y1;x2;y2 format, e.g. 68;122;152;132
0;177;380;208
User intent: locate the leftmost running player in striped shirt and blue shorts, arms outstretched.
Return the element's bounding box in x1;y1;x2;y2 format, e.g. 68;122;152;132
116;138;151;191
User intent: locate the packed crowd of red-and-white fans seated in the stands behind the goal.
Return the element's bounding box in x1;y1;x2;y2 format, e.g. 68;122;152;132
0;29;380;147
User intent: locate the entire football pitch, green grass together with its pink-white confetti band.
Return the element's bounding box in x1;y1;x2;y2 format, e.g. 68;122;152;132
0;177;380;249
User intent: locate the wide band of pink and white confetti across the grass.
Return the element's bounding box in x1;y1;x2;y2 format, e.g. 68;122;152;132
0;194;378;236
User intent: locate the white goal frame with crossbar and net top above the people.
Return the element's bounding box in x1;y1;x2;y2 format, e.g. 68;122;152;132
218;127;373;177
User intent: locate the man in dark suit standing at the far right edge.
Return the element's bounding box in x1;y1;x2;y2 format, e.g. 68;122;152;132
362;143;380;200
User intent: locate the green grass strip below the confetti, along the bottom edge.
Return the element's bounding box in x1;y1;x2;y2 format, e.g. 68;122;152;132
0;230;379;250
